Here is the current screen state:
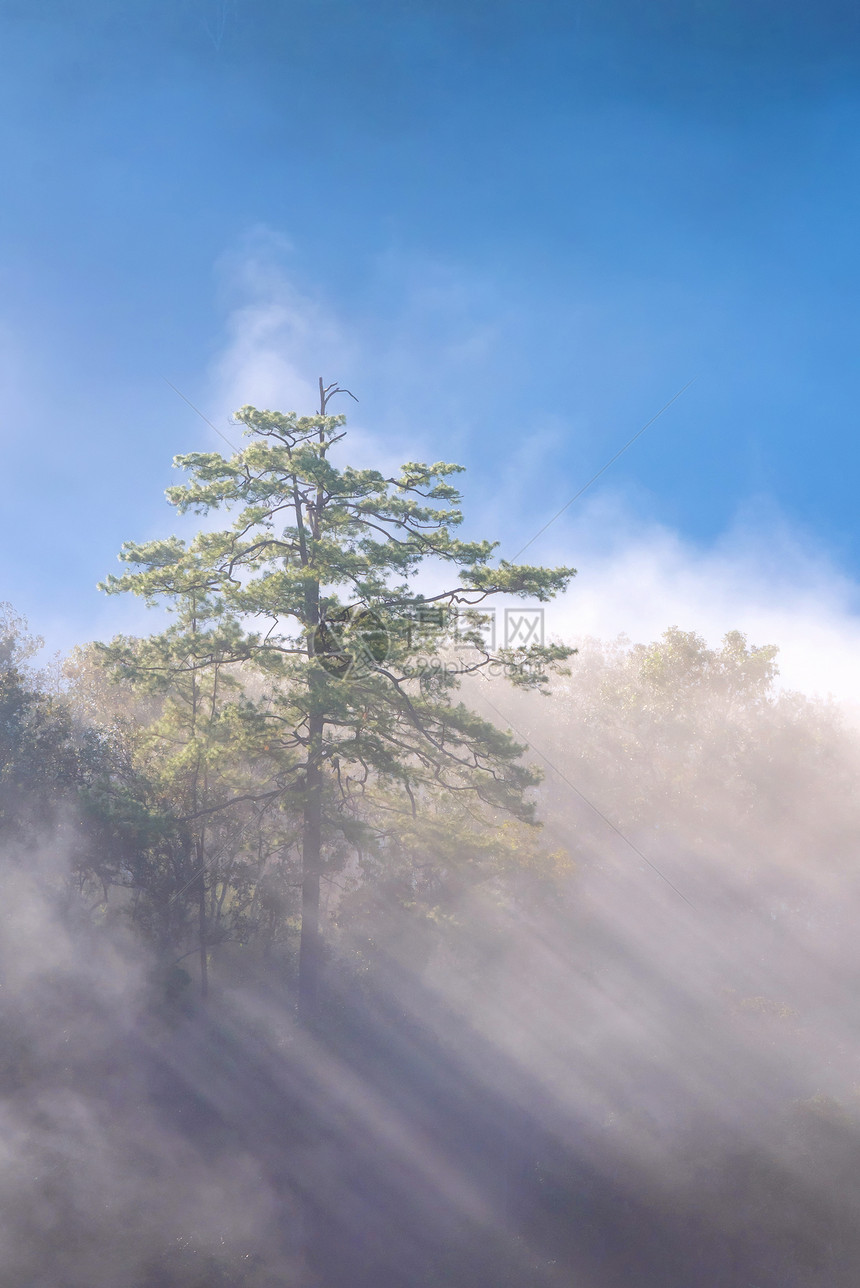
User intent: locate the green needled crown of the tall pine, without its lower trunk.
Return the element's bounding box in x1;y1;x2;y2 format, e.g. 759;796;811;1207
104;407;573;793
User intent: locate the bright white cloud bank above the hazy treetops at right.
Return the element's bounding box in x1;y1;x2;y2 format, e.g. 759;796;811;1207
538;496;860;707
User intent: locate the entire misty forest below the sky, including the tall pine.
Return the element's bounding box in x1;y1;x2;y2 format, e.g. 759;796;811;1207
0;401;860;1288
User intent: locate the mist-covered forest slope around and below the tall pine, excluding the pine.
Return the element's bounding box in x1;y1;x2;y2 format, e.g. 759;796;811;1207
0;595;860;1288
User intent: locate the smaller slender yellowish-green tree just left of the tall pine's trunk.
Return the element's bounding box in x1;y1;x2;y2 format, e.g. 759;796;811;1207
95;590;302;956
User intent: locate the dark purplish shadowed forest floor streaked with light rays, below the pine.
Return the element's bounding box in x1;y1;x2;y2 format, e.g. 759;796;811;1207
8;976;860;1288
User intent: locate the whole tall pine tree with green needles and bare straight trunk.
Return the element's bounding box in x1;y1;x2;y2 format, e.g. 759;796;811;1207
104;379;574;1016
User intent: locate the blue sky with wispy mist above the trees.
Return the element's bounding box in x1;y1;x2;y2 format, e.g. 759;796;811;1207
0;0;860;695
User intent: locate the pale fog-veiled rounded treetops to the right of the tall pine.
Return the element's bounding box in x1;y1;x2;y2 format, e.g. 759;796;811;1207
500;627;856;901
